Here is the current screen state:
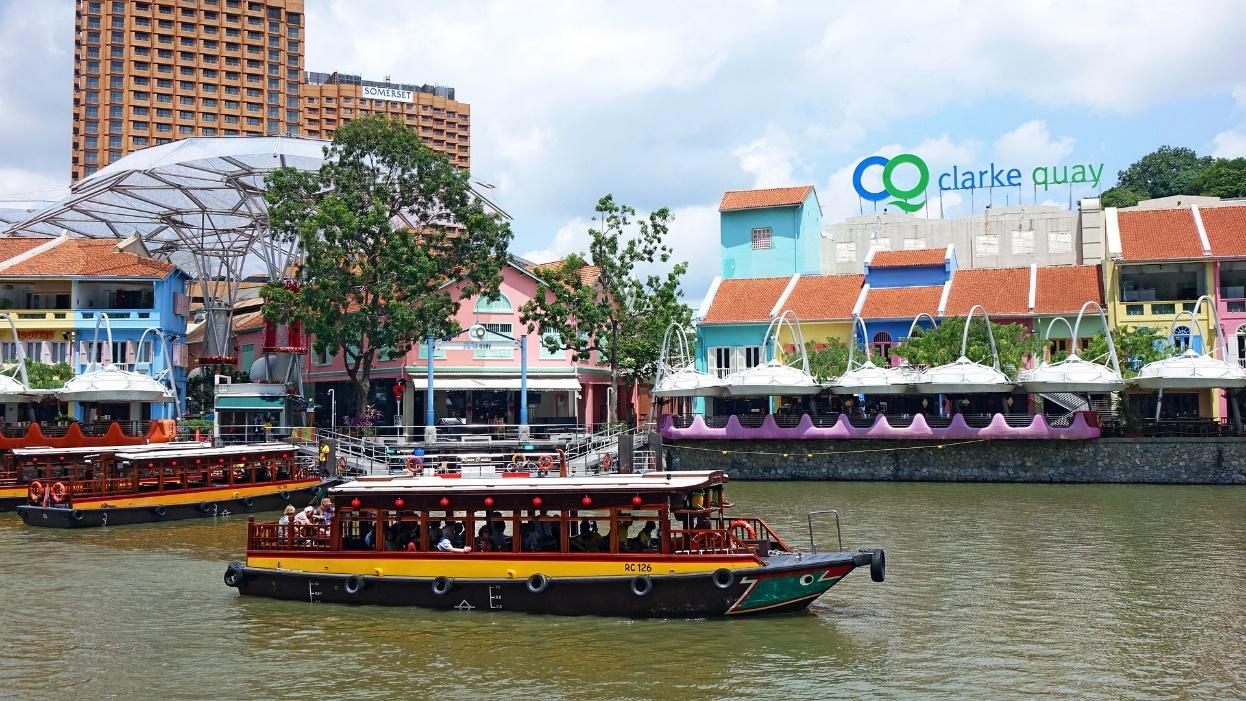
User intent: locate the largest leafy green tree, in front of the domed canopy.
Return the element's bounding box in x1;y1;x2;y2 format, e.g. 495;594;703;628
263;116;511;411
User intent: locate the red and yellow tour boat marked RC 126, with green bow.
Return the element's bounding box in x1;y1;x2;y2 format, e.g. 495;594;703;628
224;471;886;618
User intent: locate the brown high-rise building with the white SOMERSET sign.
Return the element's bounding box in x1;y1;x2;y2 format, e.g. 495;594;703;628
302;72;471;169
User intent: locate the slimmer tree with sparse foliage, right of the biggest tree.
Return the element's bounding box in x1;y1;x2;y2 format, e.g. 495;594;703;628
521;194;692;422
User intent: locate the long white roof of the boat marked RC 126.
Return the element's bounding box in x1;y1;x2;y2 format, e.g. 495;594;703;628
329;471;726;494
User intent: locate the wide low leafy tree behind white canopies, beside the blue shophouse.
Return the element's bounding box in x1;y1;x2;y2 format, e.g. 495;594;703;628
895;316;1042;377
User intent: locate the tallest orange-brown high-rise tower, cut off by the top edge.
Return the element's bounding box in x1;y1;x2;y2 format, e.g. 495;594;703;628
71;0;305;181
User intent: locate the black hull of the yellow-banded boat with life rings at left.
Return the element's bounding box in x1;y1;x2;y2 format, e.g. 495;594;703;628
17;482;331;528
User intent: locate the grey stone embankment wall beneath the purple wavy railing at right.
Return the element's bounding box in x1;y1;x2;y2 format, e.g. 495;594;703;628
664;438;1246;484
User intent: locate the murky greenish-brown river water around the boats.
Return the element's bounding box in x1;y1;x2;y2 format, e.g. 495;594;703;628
0;482;1246;700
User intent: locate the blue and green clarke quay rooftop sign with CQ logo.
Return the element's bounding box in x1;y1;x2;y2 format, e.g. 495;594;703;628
852;153;1103;214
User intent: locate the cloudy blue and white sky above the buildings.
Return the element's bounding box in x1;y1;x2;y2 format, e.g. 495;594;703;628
0;0;1246;300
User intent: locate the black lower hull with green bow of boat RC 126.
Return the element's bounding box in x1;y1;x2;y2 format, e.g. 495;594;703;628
226;552;873;619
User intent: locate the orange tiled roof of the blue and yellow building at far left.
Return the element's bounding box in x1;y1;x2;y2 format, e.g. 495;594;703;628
0;239;174;278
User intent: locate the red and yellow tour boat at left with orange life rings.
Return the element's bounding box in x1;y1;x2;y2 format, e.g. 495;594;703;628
17;443;329;528
